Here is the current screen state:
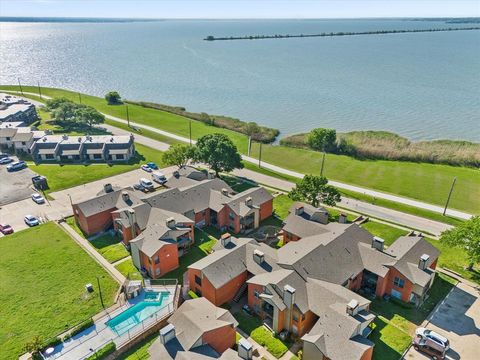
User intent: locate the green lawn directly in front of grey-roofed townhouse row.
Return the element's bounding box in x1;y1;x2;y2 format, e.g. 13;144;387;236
29;144;163;193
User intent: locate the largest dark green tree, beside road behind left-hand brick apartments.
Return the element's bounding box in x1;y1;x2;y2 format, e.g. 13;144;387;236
195;134;243;175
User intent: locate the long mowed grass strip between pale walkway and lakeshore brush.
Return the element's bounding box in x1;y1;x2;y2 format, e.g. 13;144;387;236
0;85;480;214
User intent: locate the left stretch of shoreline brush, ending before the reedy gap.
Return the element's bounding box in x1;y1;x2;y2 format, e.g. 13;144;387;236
126;101;280;143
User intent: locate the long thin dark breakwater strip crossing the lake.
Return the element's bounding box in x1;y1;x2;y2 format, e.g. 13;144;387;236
203;26;480;41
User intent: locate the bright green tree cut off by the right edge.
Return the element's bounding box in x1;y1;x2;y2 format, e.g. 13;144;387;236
440;216;480;271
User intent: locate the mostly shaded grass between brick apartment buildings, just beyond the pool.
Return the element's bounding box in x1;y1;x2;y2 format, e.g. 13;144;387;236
158;229;217;284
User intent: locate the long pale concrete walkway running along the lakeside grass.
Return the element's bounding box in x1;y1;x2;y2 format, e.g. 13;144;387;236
6;91;472;219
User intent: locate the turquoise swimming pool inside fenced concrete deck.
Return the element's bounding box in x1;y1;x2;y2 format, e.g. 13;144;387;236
107;291;170;336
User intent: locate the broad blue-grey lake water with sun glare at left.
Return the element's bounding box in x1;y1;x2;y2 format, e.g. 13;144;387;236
0;20;480;141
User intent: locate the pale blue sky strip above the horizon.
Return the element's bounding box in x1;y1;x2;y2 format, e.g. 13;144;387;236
0;0;480;18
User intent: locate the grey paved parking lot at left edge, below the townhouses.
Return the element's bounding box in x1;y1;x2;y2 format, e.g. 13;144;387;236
0;157;37;206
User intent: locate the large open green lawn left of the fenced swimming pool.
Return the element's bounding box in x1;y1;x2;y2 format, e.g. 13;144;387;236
0;223;118;359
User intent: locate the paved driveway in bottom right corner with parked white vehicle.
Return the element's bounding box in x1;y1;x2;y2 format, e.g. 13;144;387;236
405;283;480;360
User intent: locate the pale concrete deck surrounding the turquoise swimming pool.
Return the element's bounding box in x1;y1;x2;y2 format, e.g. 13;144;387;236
44;286;179;359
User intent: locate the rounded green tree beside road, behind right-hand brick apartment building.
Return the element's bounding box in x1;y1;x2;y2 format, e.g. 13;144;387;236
288;175;340;207
